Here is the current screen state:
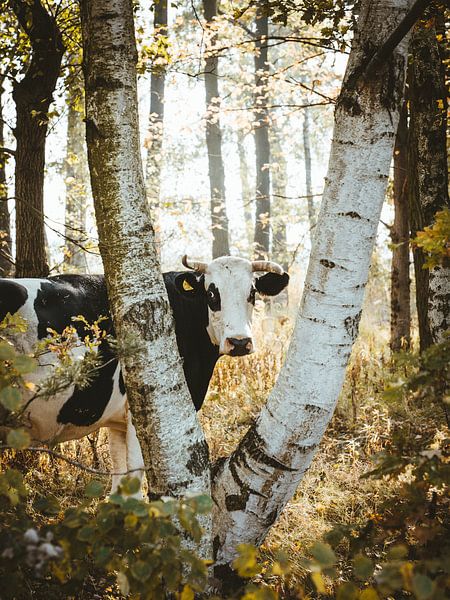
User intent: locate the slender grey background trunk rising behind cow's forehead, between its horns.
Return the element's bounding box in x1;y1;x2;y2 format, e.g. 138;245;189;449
203;0;230;258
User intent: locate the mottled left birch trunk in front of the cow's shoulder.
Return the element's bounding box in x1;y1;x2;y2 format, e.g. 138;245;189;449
81;0;209;554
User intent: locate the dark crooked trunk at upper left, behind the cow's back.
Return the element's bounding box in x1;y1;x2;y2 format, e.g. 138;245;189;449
10;0;64;277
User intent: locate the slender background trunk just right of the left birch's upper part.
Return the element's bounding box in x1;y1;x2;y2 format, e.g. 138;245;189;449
145;0;168;238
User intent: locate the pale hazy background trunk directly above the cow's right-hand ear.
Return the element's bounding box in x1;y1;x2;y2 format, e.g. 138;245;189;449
270;133;288;268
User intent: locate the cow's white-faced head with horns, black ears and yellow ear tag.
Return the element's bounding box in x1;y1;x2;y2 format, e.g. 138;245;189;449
176;256;289;356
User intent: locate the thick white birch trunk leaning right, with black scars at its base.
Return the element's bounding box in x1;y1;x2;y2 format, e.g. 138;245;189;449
213;0;408;578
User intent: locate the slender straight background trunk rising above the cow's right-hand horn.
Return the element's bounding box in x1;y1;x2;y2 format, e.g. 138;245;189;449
254;0;270;260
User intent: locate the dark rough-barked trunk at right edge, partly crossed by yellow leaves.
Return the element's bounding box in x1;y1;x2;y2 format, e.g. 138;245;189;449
408;9;450;350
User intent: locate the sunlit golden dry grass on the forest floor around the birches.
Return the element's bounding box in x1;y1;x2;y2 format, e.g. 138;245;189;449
1;308;442;600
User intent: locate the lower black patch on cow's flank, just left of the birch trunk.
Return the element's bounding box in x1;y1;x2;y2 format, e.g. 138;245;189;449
56;342;117;427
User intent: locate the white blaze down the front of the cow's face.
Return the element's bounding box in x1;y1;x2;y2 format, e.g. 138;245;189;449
205;256;254;354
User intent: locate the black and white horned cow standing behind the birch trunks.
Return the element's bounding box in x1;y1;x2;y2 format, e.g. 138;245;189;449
0;256;289;490
